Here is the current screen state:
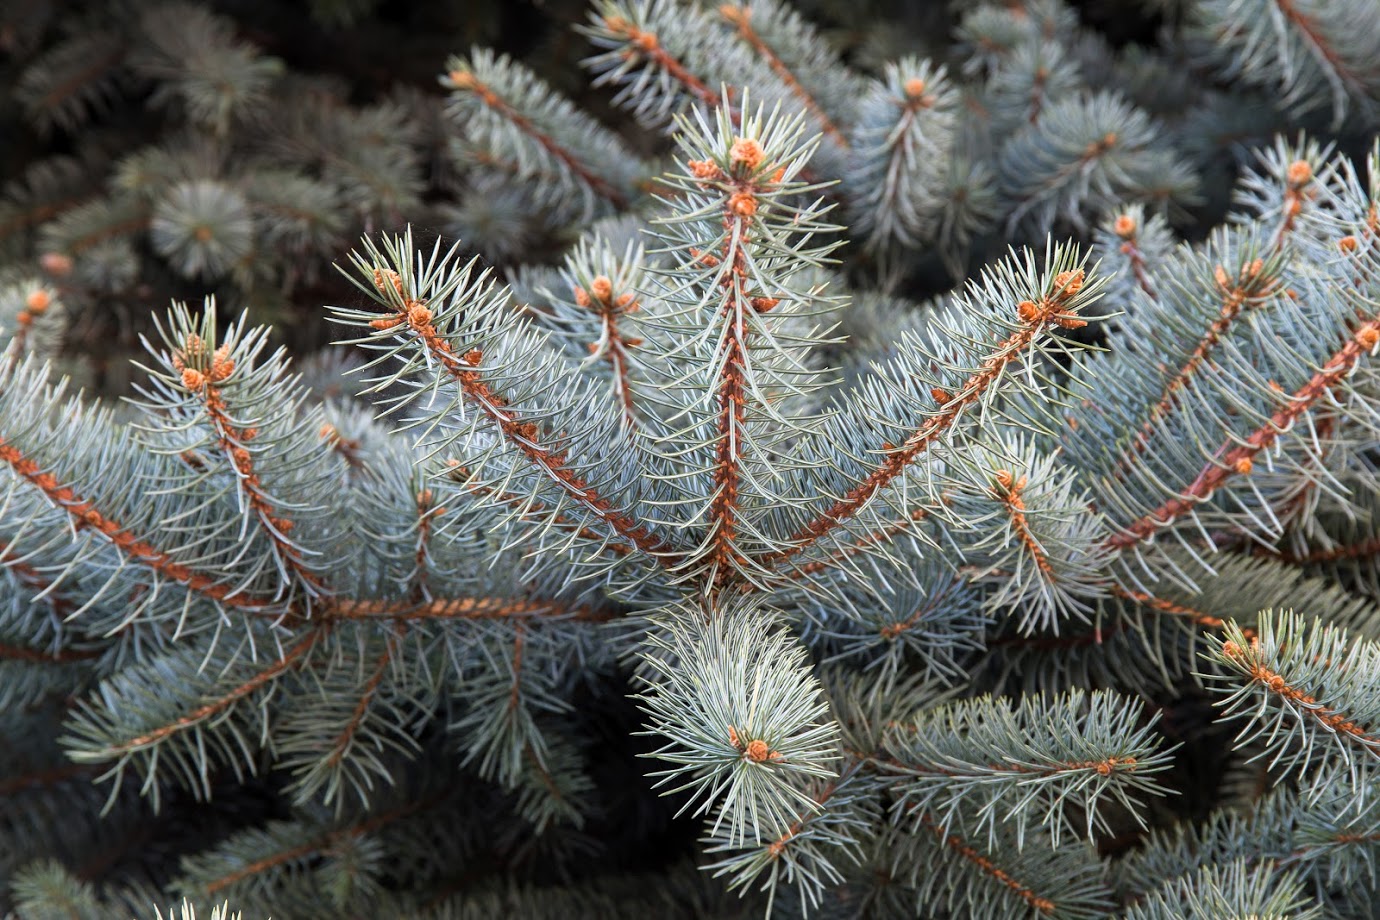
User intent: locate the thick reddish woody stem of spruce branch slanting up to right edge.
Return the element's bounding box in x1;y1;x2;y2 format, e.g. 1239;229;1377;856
1107;317;1380;550
